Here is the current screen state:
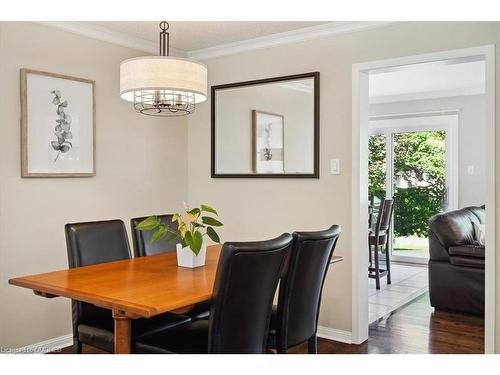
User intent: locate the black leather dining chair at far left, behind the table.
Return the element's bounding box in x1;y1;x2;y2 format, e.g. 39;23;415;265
65;220;191;353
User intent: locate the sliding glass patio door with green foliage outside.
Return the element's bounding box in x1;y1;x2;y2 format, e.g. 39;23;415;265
369;114;458;263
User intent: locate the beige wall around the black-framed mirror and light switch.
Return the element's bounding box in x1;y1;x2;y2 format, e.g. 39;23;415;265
188;22;500;340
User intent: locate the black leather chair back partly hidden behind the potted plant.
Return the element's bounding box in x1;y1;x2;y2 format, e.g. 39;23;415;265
130;215;180;257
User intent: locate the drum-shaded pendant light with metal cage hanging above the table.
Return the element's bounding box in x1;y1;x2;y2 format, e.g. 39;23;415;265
120;22;207;116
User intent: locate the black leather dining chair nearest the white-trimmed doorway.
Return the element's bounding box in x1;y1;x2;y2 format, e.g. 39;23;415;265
268;225;341;354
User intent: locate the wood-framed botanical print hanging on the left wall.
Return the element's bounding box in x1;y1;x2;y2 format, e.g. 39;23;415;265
21;69;95;177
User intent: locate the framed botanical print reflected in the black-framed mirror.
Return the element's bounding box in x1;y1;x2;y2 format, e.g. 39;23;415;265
252;109;285;174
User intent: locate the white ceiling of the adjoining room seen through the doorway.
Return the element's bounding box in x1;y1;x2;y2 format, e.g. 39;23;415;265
369;58;486;104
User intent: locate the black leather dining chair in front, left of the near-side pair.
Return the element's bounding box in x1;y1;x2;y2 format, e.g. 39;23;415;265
136;234;292;354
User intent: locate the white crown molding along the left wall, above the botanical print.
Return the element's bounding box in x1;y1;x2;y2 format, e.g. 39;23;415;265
39;21;186;57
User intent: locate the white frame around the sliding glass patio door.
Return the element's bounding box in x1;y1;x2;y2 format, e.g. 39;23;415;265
368;114;460;264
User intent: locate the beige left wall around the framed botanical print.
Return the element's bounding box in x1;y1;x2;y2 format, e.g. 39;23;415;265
0;22;187;348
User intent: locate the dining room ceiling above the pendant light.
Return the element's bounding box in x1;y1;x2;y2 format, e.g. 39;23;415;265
86;21;332;52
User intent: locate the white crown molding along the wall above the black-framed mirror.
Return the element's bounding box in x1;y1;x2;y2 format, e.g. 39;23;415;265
186;21;396;60
